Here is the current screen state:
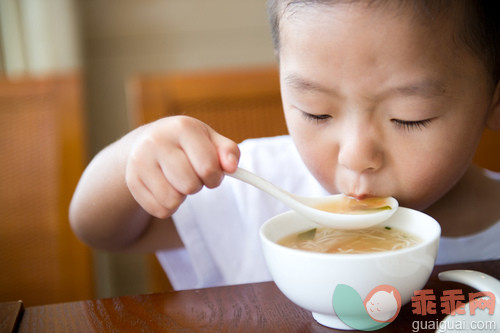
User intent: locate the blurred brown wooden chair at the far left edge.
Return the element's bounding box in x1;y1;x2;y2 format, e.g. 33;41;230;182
0;75;93;306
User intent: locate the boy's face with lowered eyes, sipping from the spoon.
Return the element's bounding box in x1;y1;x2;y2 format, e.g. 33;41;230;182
280;4;492;209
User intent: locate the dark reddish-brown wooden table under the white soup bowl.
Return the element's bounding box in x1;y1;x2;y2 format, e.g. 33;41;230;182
12;260;500;333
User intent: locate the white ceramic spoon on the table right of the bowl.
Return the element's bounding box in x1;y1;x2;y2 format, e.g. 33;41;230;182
436;270;500;333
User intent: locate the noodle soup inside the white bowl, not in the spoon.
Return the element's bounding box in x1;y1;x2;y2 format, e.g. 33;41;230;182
278;226;421;254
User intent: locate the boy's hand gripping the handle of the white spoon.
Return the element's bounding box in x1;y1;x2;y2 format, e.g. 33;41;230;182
125;116;240;218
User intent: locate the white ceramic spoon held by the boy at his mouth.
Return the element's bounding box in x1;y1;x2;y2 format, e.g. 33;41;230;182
227;168;398;229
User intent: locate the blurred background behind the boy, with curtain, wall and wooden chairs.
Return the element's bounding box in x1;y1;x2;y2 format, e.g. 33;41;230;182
0;0;500;306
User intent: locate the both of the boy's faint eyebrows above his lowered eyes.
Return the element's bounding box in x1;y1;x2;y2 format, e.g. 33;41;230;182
283;74;447;98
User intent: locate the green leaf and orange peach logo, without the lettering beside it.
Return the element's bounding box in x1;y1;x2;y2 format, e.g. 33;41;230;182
332;284;401;331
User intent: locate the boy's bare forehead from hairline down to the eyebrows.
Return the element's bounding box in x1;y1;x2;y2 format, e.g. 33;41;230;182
280;3;485;100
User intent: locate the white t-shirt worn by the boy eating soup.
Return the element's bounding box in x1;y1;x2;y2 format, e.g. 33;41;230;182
157;136;500;290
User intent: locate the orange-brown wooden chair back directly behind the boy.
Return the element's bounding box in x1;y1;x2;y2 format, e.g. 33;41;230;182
127;67;500;288
